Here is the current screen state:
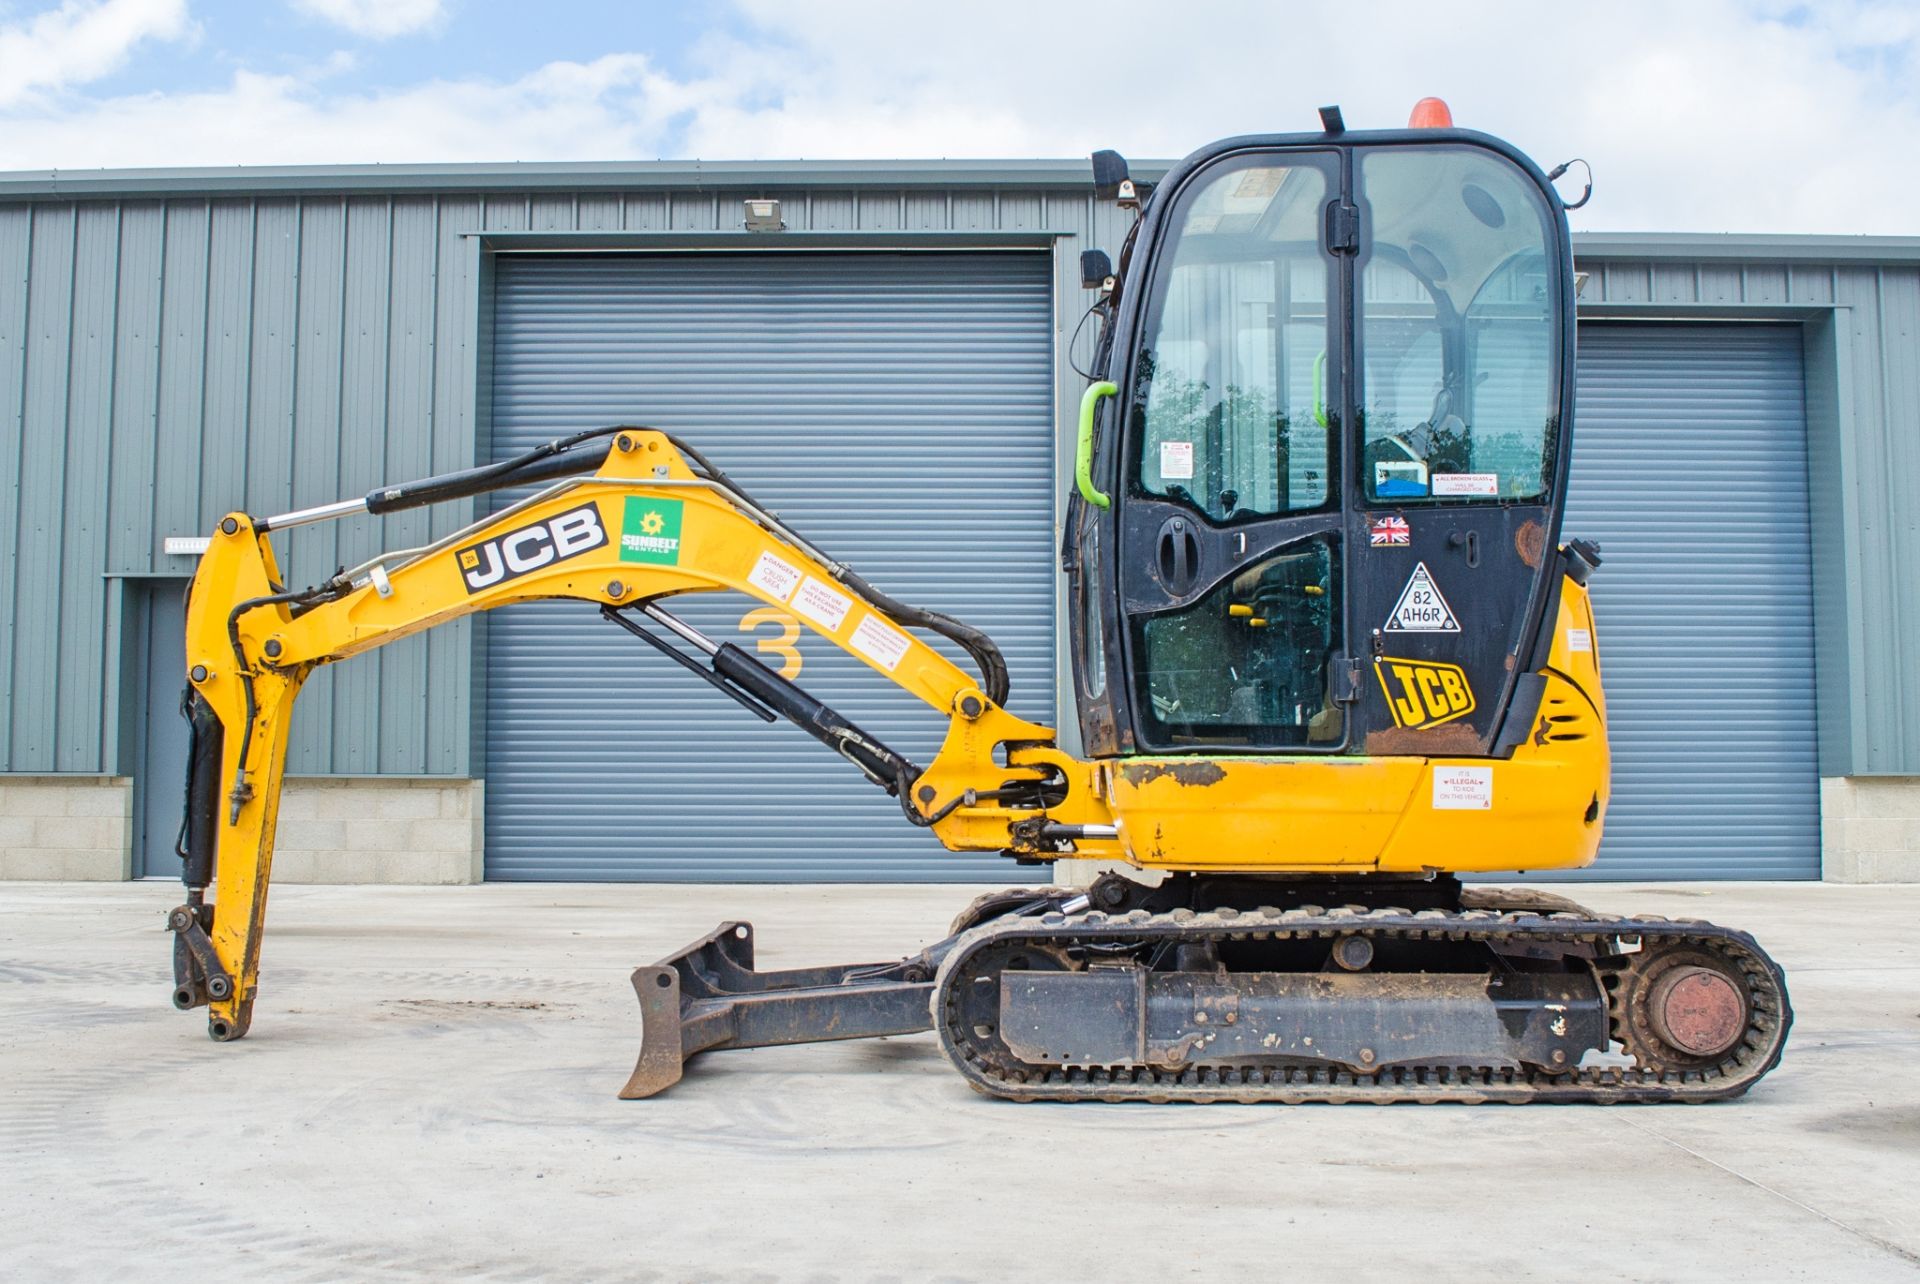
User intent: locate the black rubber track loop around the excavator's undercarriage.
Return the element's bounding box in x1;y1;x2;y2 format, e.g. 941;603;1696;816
933;906;1793;1106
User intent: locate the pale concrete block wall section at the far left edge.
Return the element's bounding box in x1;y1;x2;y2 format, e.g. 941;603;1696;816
0;775;132;883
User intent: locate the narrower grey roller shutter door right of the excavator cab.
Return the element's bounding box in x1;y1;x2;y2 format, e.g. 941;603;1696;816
1567;322;1820;879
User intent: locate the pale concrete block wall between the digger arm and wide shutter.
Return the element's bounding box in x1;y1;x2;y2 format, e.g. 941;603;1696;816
273;777;486;883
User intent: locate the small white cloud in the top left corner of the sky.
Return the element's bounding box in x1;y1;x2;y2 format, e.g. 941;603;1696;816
0;0;190;107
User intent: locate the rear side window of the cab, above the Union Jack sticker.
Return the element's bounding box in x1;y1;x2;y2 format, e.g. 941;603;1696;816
1357;148;1559;505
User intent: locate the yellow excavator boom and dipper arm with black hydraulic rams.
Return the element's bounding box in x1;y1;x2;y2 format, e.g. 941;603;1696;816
173;428;1117;1040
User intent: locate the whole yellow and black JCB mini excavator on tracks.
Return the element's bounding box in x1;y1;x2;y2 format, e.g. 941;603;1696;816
169;102;1791;1102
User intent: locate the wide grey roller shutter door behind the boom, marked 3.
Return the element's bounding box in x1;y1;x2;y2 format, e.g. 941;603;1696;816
484;251;1056;881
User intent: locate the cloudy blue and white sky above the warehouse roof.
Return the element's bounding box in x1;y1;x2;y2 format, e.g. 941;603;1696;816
0;0;1920;234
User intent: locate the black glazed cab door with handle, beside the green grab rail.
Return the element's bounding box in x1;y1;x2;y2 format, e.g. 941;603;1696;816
1116;148;1354;752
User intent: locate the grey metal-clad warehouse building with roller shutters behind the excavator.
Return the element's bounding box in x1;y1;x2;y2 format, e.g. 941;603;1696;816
0;161;1920;881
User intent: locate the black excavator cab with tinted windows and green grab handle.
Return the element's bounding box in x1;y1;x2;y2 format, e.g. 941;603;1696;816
1066;129;1590;758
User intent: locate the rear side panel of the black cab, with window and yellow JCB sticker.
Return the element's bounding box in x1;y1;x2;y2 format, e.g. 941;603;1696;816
1350;144;1571;754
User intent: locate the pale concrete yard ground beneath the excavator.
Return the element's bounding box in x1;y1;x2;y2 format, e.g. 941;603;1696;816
0;883;1920;1280
